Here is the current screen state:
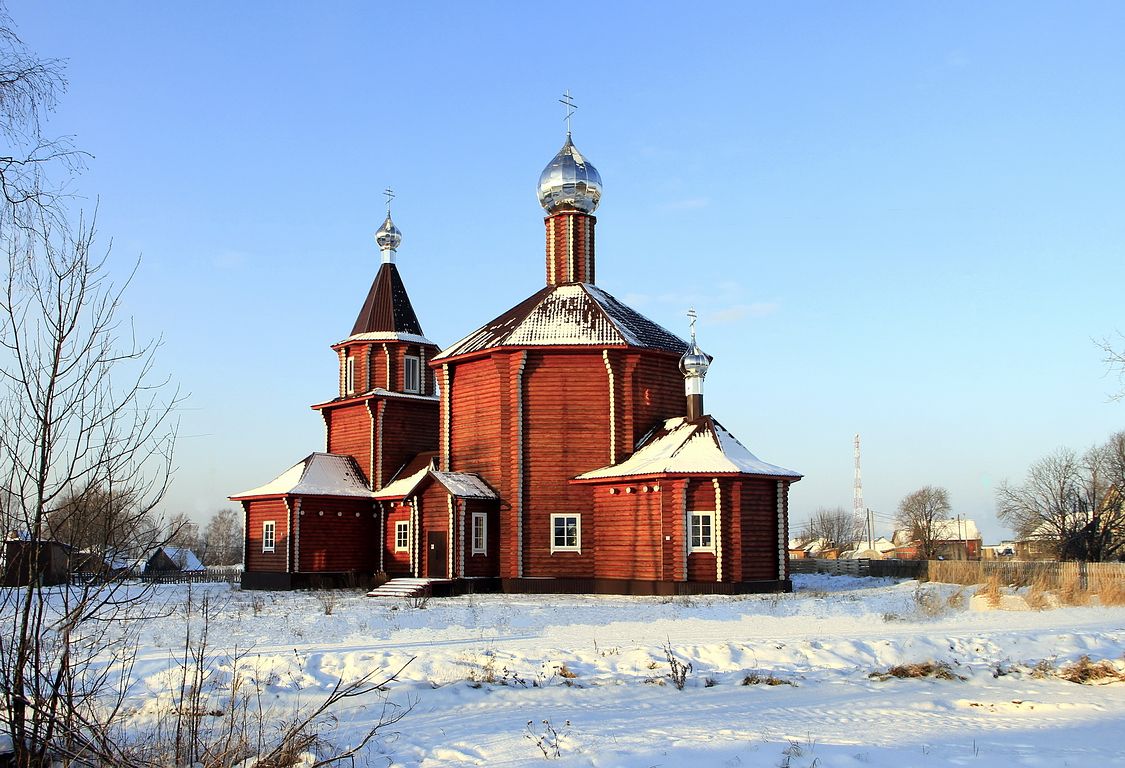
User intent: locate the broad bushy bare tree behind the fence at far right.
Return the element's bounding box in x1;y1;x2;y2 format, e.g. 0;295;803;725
997;433;1125;561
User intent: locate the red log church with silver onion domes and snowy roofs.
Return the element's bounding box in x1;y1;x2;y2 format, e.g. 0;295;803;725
231;124;801;595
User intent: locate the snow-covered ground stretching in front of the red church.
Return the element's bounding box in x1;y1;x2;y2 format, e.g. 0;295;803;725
92;576;1125;768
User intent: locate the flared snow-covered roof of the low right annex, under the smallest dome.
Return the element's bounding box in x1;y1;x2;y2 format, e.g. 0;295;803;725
577;416;801;480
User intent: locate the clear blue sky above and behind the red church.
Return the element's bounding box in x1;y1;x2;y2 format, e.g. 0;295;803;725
8;0;1125;540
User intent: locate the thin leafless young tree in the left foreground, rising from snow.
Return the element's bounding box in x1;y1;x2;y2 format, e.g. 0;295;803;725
0;209;178;766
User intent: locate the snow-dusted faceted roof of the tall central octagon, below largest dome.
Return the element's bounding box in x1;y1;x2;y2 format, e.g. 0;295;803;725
434;282;687;360
